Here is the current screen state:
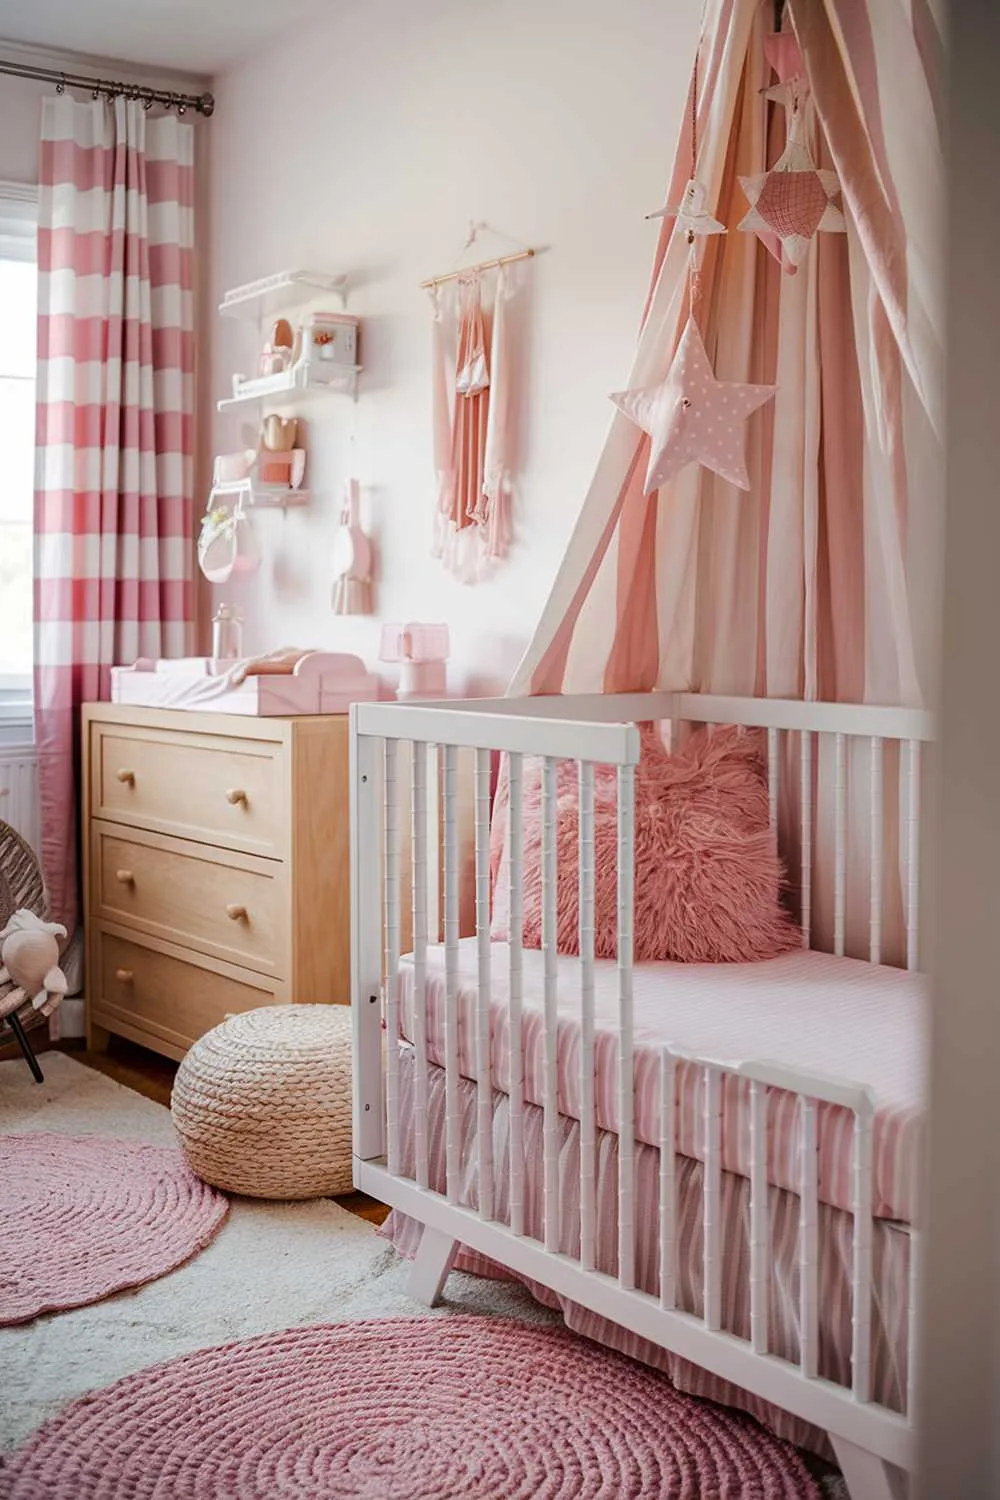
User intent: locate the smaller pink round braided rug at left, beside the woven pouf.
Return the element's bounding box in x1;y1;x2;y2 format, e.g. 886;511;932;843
0;1134;229;1325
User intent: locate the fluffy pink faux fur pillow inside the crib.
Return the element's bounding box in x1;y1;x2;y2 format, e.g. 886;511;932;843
492;726;799;963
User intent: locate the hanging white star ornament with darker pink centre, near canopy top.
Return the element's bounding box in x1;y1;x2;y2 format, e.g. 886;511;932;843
738;138;847;267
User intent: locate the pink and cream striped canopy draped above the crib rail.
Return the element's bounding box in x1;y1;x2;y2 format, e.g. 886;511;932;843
511;0;943;705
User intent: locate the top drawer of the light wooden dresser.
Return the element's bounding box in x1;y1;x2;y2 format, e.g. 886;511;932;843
90;723;288;858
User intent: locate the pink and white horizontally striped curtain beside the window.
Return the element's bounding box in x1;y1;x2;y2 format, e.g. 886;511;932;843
34;95;195;932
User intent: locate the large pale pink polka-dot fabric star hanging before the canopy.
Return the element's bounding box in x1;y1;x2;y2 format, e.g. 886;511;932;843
612;318;778;495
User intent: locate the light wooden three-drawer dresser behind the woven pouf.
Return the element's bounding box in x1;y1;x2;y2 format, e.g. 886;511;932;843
82;704;351;1058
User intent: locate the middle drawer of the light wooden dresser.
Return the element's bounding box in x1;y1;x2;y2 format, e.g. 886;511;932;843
90;822;288;977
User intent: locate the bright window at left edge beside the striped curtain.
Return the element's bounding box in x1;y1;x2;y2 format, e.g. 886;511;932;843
0;183;37;720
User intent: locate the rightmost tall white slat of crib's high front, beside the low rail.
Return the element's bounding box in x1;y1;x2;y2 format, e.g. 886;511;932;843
618;765;636;1292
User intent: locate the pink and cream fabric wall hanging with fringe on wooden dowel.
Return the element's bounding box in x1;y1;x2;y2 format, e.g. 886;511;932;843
423;224;534;584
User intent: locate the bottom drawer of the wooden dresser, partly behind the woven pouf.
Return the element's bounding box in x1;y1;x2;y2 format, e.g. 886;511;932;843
90;927;276;1058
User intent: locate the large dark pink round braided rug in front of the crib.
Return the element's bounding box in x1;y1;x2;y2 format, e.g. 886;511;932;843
0;1316;819;1500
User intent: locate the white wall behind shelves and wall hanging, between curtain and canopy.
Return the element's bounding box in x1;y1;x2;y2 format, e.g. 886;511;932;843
202;0;702;690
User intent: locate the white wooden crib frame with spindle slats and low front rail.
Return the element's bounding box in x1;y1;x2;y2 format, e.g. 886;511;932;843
351;693;931;1500
